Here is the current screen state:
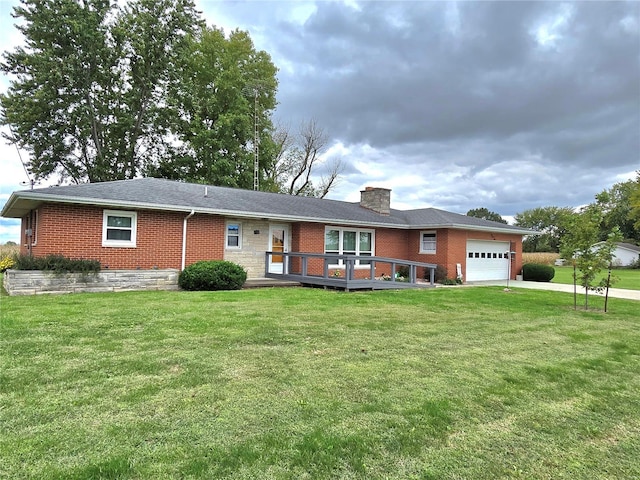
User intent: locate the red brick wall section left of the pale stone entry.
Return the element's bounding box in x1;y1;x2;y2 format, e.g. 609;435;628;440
22;204;224;269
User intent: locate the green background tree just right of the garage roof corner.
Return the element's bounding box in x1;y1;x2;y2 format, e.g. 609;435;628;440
515;207;575;252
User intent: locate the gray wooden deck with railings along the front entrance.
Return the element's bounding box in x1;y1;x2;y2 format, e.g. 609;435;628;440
265;252;436;291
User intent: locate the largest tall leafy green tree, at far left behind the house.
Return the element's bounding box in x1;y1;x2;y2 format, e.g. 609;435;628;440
0;0;202;182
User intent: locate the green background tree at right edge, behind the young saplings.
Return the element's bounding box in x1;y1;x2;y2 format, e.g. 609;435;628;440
595;180;640;243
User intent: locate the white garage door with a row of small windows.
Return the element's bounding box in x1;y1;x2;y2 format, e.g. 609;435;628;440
465;240;510;282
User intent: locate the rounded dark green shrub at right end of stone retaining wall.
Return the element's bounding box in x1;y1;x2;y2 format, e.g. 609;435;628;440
178;260;247;290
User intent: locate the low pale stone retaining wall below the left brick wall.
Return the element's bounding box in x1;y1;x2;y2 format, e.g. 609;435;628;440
4;269;180;295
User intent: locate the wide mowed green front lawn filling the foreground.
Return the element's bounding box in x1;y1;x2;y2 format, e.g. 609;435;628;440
0;287;640;479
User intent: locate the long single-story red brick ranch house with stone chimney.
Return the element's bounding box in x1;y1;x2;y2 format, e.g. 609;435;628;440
2;178;531;282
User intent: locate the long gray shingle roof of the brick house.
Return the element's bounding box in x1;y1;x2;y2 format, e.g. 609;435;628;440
2;178;532;234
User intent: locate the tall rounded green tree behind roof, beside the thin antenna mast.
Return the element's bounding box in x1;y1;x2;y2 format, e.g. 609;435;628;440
152;27;278;189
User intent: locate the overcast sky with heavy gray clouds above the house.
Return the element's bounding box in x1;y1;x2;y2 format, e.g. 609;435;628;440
0;0;640;242
